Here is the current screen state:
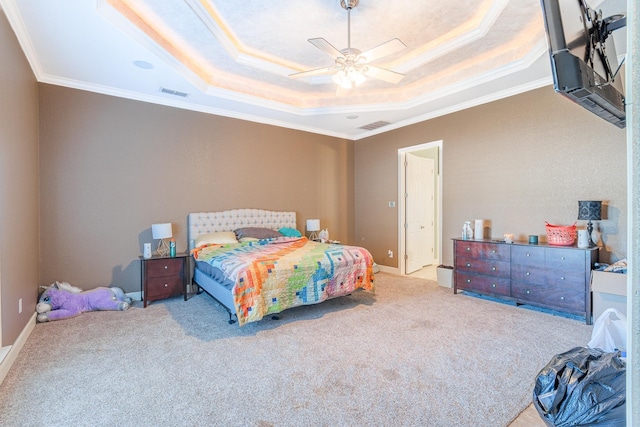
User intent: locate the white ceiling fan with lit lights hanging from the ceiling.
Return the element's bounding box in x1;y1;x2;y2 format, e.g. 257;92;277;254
289;0;406;89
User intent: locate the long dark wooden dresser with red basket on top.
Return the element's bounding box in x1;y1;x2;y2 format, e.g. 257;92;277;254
453;239;599;324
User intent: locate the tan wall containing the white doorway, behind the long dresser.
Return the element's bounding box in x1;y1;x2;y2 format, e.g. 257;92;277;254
355;87;627;267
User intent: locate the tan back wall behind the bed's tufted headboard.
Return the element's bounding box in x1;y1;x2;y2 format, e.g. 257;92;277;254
40;85;354;292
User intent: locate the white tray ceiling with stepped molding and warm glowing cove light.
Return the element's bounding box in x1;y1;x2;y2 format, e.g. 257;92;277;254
0;0;626;139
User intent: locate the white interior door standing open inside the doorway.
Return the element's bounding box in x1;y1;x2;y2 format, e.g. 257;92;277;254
404;153;435;274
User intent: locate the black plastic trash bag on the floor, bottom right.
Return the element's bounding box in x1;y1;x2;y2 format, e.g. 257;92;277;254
533;347;626;427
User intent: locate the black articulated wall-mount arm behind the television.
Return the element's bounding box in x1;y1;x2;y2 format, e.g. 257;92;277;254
578;0;627;82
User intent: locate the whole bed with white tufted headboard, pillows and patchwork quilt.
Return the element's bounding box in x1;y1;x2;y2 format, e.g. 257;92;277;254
187;209;374;326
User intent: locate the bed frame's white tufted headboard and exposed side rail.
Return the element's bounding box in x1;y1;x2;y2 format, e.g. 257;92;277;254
187;209;297;323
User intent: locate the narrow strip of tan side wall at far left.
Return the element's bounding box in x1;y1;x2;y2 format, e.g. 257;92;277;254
0;9;39;346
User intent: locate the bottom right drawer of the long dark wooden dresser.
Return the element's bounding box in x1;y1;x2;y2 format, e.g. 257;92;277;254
511;281;585;313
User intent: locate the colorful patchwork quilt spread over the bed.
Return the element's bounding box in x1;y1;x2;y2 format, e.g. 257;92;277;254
193;237;374;326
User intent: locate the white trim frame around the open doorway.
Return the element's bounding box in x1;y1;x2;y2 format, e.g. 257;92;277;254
398;140;443;276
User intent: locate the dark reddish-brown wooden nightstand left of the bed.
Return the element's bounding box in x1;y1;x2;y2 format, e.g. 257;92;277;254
140;253;189;307
